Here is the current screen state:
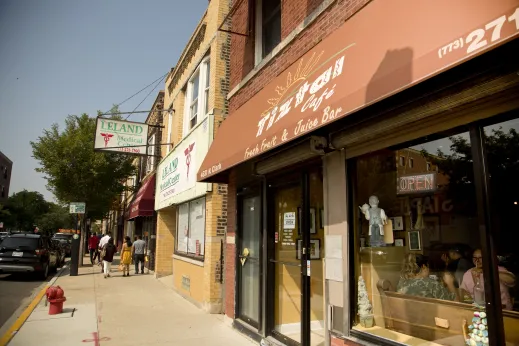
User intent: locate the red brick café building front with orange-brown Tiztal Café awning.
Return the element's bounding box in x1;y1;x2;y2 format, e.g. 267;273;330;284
198;0;519;346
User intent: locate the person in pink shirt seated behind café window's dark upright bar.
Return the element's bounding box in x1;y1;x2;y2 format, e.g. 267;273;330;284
460;249;515;310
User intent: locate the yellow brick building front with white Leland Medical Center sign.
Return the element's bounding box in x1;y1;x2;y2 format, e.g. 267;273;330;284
155;0;230;313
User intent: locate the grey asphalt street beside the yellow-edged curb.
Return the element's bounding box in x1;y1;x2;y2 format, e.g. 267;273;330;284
0;273;53;328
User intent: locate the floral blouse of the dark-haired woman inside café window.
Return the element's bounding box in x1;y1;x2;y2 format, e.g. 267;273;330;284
396;278;456;300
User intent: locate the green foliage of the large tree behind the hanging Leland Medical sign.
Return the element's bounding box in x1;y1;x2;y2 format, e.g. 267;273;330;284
31;107;135;218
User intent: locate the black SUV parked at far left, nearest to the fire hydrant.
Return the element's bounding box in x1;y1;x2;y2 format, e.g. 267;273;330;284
0;233;59;279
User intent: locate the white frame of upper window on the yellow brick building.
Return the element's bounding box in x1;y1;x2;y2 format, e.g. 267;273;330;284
183;56;211;137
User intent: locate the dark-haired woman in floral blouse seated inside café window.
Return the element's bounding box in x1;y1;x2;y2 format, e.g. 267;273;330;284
397;253;459;300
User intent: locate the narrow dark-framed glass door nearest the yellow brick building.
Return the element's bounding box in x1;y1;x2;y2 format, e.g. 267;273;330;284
237;195;261;328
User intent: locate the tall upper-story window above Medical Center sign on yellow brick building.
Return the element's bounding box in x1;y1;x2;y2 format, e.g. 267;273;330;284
184;57;210;136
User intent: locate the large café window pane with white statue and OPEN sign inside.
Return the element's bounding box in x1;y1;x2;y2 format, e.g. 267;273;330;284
348;132;488;345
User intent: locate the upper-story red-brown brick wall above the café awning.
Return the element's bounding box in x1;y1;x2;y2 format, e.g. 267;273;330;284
229;0;370;115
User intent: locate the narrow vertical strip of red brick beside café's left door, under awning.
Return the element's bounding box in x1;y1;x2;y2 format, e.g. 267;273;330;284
224;172;236;318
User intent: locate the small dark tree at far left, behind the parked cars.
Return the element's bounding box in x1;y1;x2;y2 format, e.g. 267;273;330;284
5;190;49;232
